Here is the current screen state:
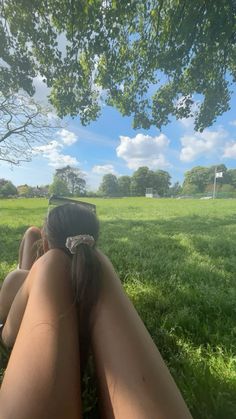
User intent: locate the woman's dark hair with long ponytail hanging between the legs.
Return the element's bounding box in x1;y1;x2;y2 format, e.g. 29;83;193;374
45;203;101;374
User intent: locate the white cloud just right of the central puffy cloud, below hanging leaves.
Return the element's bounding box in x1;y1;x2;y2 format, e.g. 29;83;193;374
180;127;228;162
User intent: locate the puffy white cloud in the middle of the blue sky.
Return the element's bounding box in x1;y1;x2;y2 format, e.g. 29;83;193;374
116;134;170;170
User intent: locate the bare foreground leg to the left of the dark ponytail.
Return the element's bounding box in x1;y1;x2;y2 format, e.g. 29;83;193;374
0;250;81;419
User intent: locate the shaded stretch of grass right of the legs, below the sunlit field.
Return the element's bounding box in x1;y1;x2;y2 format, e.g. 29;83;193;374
101;216;236;419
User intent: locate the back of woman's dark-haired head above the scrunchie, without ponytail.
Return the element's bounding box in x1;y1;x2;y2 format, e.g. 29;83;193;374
44;203;99;251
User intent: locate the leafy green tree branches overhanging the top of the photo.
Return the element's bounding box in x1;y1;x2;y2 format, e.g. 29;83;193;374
0;0;236;131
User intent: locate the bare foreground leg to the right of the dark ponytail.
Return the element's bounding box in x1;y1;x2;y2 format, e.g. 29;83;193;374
92;251;194;419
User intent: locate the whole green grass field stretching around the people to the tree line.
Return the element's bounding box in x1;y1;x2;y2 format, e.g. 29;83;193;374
0;198;236;419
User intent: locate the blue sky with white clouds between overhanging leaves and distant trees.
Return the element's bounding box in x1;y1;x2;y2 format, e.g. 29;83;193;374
0;77;236;191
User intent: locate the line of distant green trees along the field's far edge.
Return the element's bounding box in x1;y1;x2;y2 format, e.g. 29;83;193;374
0;164;236;198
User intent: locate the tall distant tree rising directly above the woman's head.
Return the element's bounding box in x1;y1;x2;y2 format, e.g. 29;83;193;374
55;165;86;196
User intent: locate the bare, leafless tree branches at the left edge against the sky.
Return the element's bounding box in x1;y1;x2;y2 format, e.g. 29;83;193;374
0;93;60;165
